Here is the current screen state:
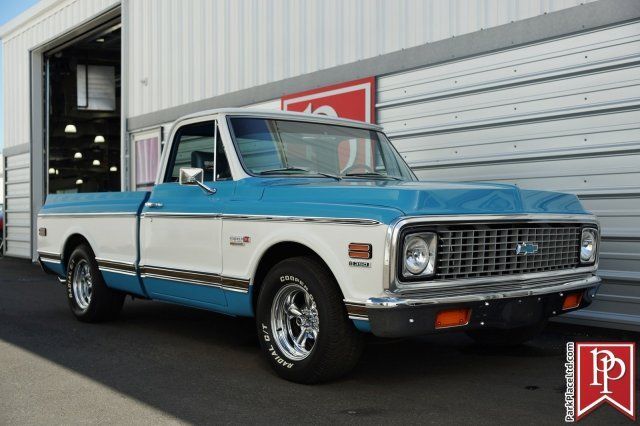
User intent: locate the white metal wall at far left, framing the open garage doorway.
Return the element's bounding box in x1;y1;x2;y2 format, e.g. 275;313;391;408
2;0;119;258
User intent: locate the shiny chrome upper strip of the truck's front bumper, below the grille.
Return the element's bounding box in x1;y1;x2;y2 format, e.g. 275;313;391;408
366;275;602;309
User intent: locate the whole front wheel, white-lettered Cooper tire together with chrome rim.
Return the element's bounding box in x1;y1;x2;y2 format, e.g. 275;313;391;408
256;256;364;384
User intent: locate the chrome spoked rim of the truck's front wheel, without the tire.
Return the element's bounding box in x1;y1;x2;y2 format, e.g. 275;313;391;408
271;284;320;361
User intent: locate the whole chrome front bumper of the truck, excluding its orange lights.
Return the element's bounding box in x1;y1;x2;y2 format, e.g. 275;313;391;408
360;275;601;337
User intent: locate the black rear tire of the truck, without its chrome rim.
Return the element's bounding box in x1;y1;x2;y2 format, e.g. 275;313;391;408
67;244;126;322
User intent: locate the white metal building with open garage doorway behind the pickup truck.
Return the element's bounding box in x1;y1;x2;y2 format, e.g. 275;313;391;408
0;0;640;330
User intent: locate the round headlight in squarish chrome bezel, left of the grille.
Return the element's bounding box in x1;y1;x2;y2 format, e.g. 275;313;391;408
402;232;438;277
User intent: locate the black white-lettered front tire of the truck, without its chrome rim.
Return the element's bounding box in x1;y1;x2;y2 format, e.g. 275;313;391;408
256;256;364;384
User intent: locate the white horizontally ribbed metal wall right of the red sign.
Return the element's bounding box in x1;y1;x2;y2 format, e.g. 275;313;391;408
377;23;640;329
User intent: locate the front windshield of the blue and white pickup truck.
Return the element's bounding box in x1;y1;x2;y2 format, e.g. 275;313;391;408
229;117;415;180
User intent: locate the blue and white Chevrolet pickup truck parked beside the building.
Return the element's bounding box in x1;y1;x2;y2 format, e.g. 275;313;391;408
38;109;600;383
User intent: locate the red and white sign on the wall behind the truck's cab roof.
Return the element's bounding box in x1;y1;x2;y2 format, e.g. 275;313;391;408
281;77;376;123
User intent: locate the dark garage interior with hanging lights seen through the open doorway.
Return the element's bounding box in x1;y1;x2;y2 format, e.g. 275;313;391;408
44;20;122;194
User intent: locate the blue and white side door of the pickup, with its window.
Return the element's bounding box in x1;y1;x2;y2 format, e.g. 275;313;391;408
140;120;233;309
